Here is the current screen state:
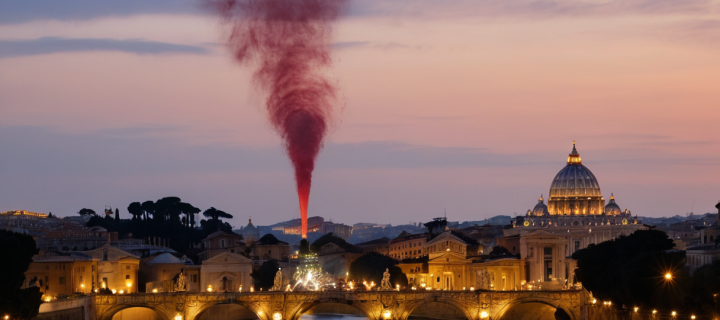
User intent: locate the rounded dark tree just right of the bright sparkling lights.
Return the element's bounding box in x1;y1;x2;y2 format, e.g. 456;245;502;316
349;252;408;287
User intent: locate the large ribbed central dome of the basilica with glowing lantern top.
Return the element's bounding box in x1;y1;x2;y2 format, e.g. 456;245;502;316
548;142;605;215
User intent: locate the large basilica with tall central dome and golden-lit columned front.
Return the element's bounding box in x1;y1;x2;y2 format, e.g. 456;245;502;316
498;143;647;287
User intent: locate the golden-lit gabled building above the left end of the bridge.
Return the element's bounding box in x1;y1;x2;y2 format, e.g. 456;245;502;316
85;244;140;293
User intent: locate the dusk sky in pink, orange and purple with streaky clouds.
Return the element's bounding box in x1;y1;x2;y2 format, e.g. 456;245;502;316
0;0;720;227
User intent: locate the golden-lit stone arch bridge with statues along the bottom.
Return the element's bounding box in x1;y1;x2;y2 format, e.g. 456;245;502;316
94;289;592;320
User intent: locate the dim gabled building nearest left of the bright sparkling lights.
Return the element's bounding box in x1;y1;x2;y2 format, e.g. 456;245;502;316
200;251;253;292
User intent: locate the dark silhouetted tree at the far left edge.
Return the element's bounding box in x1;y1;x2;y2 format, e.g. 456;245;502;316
0;230;42;319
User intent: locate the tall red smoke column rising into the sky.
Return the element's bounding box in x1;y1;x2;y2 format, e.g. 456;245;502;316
205;0;347;238
